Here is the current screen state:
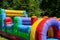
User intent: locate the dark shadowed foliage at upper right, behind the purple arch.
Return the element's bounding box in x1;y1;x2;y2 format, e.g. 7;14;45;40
41;0;60;17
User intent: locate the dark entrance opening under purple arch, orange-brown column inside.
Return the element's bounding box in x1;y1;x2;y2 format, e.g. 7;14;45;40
47;26;59;39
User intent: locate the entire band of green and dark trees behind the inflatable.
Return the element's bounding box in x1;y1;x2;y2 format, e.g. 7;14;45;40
0;0;60;17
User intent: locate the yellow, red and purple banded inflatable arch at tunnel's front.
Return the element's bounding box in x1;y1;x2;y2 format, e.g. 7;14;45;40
30;17;60;40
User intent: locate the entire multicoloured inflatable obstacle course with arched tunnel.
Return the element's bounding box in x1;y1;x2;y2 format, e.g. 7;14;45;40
0;9;60;40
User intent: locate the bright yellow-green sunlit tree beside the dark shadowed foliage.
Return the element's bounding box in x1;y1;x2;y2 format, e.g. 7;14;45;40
28;0;41;16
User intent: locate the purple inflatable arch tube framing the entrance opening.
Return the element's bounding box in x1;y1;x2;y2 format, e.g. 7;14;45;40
42;18;60;40
